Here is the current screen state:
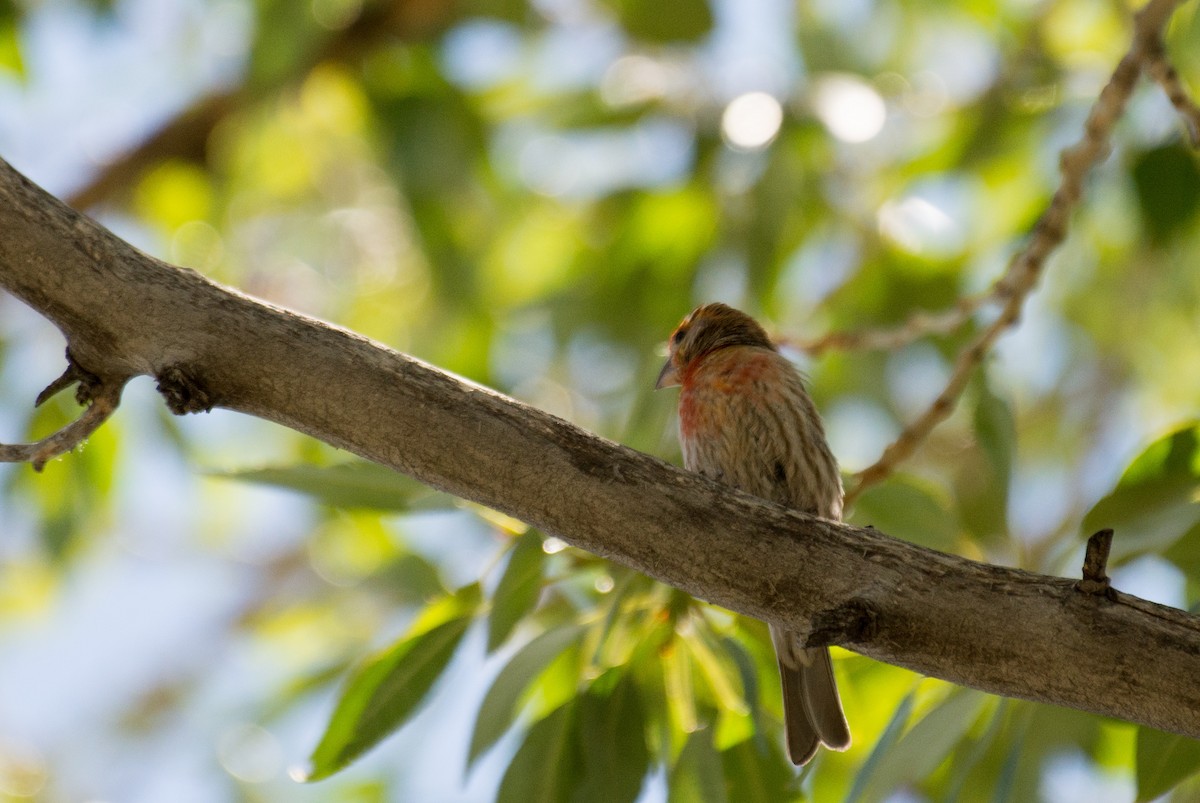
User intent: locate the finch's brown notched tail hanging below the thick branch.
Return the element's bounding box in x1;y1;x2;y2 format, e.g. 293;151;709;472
770;625;850;765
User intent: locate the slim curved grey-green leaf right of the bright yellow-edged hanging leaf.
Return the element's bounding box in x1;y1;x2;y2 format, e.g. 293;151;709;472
467;625;583;767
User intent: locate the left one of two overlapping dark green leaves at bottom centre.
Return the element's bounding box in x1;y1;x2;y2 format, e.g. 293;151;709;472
496;700;580;803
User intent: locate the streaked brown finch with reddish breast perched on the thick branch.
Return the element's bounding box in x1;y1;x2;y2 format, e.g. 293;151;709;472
655;304;850;765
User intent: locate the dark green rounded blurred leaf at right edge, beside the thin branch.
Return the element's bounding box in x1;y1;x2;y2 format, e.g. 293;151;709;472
1133;144;1200;242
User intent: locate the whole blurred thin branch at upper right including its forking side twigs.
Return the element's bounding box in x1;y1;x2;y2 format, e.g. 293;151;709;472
844;0;1200;508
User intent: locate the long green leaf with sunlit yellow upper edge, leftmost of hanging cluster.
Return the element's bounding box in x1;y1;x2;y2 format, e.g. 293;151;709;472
305;586;479;781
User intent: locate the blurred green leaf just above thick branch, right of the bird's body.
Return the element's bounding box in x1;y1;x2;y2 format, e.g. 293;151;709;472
850;475;959;552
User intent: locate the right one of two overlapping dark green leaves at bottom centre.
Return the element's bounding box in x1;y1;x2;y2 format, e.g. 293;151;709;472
576;670;650;803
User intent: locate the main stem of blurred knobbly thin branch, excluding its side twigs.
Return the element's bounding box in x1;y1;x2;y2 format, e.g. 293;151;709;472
845;0;1181;508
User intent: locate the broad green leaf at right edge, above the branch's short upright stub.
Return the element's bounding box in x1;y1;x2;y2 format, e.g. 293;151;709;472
1082;423;1200;562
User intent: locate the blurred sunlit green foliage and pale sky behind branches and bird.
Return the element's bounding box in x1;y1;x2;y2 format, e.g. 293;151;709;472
0;0;1200;801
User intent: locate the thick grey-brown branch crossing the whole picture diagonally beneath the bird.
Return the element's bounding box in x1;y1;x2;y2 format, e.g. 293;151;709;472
0;154;1200;737
